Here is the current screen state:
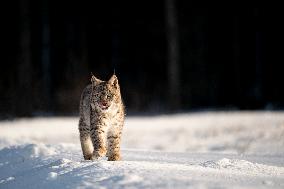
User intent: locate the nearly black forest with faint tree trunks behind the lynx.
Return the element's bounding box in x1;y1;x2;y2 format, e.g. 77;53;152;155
0;0;284;118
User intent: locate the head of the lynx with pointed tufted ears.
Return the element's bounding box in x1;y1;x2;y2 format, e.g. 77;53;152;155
91;74;121;111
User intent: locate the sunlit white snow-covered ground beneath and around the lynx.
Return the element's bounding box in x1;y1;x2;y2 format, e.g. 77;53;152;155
0;112;284;189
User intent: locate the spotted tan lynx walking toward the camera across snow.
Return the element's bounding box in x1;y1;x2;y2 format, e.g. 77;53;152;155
79;74;125;161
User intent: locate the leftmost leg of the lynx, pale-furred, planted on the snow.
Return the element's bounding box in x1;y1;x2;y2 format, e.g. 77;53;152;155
79;120;93;160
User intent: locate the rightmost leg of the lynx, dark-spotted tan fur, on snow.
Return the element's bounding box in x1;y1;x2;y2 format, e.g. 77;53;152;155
107;131;121;161
